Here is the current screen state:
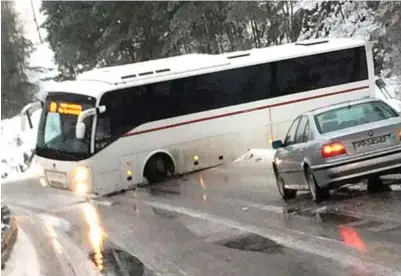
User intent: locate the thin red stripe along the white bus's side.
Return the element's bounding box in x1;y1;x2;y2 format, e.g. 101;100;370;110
124;86;369;136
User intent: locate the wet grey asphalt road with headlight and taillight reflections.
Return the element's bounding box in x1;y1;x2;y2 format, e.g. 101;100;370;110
2;157;401;276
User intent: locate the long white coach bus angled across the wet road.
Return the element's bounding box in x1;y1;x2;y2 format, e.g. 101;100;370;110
21;39;375;195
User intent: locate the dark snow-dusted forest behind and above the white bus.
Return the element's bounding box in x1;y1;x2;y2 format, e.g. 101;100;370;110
1;1;401;118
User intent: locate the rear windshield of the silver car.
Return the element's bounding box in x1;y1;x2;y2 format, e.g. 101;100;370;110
314;101;398;134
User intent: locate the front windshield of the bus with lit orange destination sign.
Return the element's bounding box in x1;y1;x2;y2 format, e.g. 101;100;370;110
36;93;96;161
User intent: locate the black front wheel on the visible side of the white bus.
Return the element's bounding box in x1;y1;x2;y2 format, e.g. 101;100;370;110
144;153;174;184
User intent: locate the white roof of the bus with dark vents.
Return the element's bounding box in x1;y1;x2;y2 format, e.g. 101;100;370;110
52;38;366;98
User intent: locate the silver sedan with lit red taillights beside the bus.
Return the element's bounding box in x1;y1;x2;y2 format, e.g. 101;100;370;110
273;98;401;202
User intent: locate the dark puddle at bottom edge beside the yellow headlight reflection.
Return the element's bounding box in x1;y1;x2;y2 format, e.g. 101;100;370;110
89;248;144;276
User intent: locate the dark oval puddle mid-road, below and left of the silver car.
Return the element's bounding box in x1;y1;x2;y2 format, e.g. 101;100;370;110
215;233;283;254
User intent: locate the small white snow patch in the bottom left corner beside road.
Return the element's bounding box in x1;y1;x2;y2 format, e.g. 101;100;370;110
1;228;40;276
